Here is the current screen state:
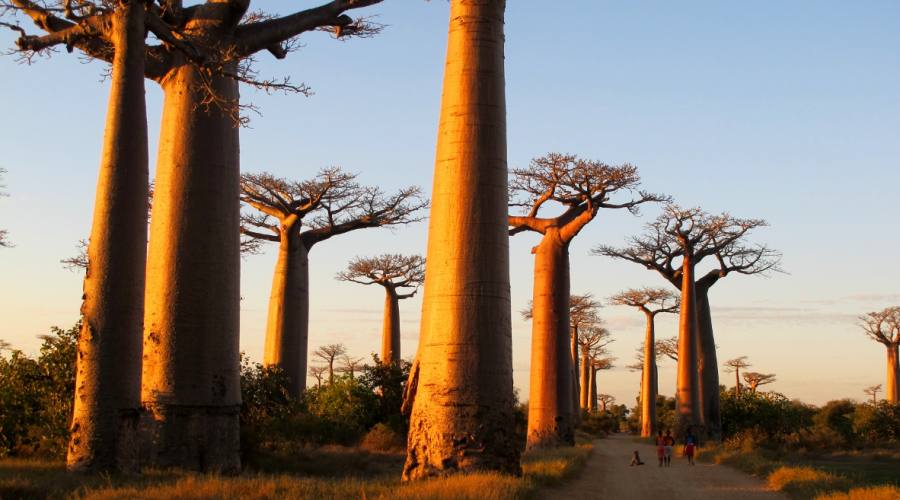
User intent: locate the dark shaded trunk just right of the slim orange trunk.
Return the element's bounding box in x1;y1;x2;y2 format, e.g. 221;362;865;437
695;285;722;441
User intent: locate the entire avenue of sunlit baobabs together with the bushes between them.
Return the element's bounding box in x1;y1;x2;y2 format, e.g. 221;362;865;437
0;0;900;486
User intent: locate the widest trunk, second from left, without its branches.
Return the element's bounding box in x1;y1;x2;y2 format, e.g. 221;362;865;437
141;64;241;472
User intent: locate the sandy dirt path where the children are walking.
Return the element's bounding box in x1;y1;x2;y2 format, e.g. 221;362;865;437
540;435;788;500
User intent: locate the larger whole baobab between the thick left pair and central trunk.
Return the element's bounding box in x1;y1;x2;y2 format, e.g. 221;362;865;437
241;168;428;395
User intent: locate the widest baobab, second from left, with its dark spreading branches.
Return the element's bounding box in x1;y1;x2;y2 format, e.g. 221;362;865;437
0;0;390;471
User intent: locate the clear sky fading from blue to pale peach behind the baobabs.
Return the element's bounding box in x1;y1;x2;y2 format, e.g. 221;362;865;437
0;0;900;406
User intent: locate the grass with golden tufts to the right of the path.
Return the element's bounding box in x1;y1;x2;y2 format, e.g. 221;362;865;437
700;445;900;500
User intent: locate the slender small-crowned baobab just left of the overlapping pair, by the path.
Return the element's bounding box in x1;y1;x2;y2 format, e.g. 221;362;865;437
609;288;679;437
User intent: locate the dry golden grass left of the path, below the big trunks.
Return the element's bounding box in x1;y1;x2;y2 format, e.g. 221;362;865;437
0;444;592;500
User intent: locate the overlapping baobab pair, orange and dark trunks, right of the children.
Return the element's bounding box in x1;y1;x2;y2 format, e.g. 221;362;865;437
592;205;781;439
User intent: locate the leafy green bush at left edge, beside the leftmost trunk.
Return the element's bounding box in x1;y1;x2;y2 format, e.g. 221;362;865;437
0;322;81;458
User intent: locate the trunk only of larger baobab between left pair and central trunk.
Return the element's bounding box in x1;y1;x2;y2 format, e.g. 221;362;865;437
263;226;309;395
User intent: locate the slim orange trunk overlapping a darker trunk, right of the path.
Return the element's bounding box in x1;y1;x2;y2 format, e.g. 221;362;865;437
675;252;703;436
